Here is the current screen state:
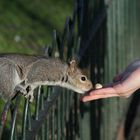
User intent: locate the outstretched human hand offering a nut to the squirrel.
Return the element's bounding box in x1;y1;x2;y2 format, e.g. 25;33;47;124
82;59;140;102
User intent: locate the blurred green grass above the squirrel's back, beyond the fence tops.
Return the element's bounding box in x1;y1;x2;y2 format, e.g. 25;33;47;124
0;0;74;54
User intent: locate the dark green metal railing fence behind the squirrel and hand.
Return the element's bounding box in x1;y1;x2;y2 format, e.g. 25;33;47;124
0;0;140;140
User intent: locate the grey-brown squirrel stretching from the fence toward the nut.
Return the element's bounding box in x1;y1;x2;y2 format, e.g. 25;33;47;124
0;53;92;102
